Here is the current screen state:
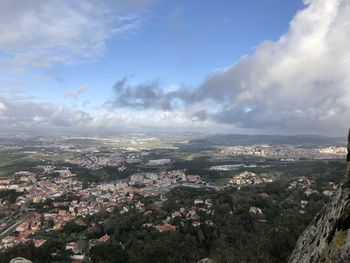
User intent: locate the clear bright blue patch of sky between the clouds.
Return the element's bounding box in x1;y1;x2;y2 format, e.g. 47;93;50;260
39;0;304;107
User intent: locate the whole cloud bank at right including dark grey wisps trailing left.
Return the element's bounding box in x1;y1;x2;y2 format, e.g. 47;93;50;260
107;0;350;135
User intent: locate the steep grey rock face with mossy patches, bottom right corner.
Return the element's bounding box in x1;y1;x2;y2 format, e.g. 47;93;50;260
289;131;350;263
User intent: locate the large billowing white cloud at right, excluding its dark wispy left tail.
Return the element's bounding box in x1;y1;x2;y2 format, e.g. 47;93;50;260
200;0;350;134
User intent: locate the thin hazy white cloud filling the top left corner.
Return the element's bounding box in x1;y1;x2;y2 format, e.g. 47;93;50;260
0;0;150;69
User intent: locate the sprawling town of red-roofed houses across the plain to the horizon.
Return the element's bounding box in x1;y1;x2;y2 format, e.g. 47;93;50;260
0;137;345;261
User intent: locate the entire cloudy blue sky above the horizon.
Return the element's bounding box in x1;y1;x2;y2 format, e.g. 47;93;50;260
0;0;350;135
